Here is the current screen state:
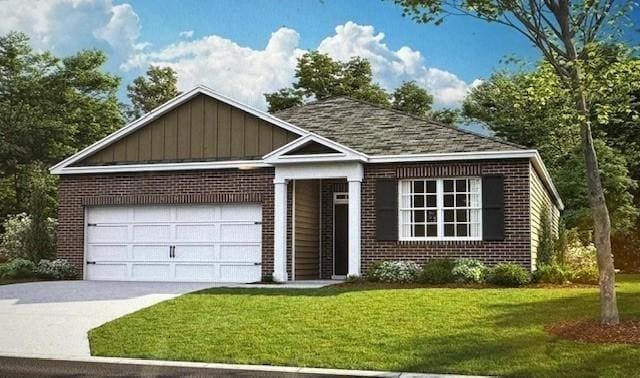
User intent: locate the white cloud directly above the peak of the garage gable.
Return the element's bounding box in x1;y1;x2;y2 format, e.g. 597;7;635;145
122;28;304;108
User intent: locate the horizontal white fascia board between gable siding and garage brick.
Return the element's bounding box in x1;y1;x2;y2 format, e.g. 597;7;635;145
51;160;271;175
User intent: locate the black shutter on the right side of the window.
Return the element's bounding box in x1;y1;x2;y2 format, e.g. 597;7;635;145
482;175;504;240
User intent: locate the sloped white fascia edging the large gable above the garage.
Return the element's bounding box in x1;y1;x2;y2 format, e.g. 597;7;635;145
49;85;309;174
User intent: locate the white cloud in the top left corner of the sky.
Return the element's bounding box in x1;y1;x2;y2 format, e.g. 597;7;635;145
0;0;147;58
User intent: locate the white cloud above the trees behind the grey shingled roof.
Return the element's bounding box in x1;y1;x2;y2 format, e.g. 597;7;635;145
318;21;471;106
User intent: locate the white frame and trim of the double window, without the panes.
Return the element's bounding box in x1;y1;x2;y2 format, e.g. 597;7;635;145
398;176;482;241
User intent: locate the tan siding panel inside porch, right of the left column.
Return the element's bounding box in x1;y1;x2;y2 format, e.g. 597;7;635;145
293;180;320;280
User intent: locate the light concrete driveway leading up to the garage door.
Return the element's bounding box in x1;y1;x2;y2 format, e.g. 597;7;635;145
0;281;216;357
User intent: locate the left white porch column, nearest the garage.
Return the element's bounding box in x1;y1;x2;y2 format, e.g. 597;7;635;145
273;181;288;282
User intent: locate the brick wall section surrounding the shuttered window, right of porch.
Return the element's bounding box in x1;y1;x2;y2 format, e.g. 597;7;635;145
362;159;531;272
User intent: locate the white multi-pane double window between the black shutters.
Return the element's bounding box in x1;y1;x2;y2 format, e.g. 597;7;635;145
399;178;482;240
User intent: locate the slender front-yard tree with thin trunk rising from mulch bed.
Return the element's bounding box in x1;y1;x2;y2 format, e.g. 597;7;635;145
394;0;634;325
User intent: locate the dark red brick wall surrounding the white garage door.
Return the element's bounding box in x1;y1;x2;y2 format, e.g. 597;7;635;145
57;168;274;277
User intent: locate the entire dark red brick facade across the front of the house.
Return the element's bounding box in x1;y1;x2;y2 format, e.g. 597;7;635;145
58;159;531;279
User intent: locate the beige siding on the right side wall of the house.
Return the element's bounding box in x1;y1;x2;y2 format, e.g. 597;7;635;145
529;165;560;270
